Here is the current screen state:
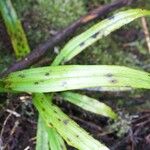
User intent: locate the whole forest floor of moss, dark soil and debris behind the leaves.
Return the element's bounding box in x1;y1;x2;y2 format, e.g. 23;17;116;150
0;0;150;150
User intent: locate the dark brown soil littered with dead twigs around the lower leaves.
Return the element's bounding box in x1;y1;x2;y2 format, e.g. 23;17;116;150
0;94;150;150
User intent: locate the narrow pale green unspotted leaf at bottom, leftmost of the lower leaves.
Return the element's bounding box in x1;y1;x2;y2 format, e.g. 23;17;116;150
36;117;50;150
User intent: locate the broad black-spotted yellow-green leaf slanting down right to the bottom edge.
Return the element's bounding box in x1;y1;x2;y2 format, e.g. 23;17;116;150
33;93;108;150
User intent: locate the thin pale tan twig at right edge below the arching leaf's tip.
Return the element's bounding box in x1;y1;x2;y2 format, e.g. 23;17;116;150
141;17;150;53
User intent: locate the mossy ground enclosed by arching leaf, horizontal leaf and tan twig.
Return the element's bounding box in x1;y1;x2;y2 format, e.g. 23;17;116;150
69;17;150;71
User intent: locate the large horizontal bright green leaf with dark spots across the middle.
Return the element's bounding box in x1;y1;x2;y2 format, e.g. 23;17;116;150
3;65;150;92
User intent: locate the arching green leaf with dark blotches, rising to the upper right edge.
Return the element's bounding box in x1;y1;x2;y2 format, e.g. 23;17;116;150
53;9;150;65
